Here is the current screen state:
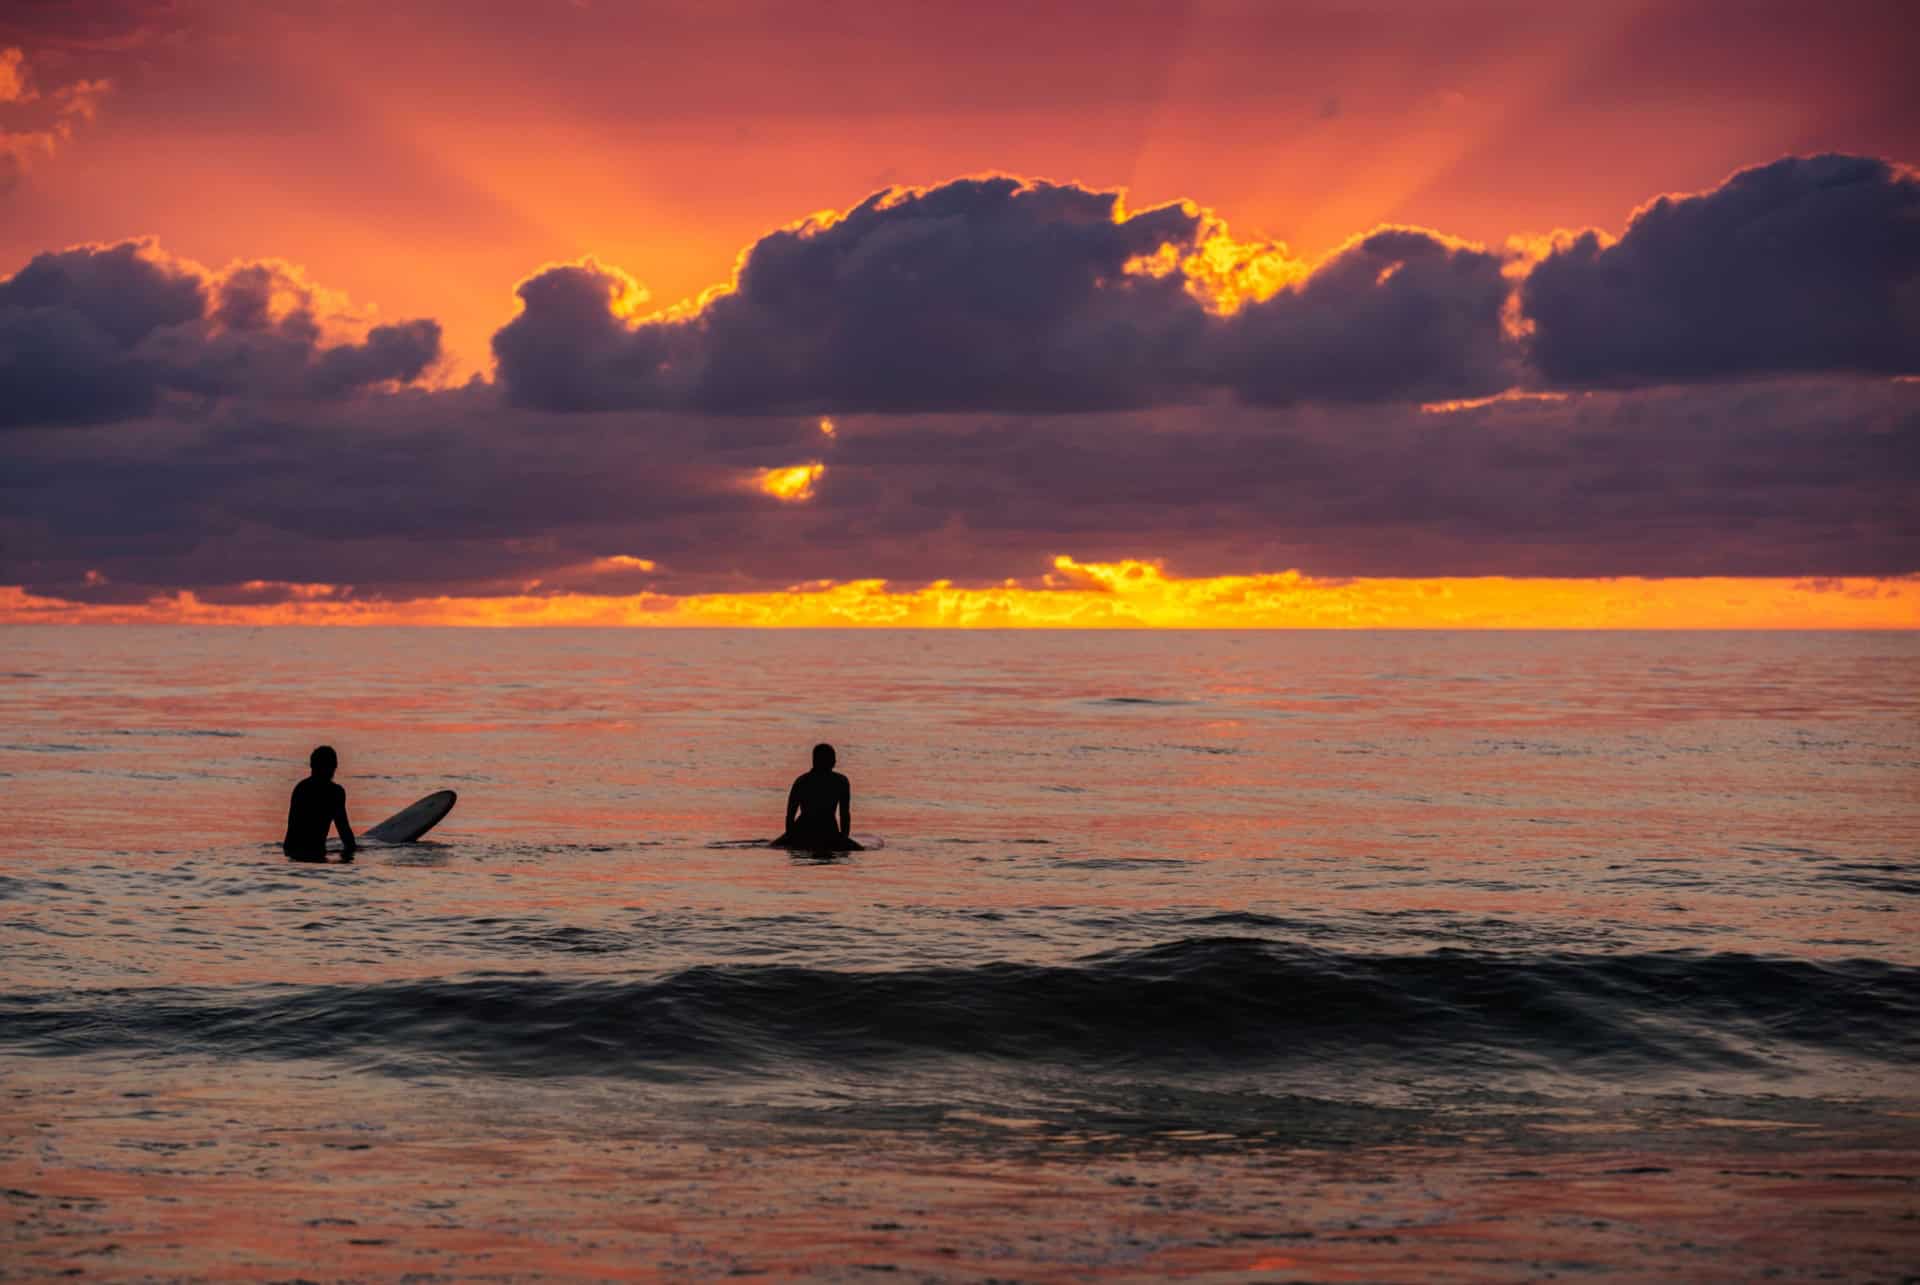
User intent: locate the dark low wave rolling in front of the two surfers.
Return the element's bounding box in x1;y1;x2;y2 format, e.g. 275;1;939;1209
0;937;1920;1078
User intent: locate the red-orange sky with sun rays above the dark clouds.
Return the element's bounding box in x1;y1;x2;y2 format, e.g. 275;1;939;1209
0;0;1920;373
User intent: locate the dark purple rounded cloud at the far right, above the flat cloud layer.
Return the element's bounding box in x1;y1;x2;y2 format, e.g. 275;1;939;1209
1521;156;1920;384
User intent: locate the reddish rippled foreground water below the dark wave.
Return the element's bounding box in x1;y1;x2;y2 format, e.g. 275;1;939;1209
11;1062;1920;1281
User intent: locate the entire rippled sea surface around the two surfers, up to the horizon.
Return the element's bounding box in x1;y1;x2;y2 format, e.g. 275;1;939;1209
0;626;1920;1279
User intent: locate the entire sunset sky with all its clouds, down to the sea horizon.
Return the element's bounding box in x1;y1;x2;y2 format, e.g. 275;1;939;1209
0;0;1920;628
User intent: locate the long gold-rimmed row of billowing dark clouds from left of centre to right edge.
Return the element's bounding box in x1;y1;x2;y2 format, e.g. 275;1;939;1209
493;156;1920;413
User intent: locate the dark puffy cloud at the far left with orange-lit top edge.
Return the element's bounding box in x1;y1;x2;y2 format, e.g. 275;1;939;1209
0;240;440;428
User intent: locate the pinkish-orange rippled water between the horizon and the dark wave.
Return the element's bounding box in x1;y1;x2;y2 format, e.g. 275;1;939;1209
0;628;1920;985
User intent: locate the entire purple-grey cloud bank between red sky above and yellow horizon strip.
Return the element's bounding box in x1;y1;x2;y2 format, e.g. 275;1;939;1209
0;156;1920;599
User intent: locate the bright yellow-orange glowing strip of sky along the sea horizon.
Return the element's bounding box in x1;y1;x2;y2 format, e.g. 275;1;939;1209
0;555;1920;630
